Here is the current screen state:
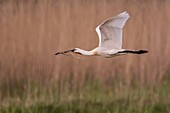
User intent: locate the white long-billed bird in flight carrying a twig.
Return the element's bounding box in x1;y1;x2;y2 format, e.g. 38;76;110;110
55;11;148;58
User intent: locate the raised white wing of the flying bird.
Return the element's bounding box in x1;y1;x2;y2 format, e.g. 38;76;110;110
96;11;130;50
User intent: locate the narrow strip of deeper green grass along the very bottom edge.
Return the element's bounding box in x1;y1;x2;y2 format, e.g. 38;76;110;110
0;100;170;113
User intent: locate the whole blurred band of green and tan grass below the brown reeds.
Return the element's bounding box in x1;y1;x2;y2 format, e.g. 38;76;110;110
0;75;170;113
